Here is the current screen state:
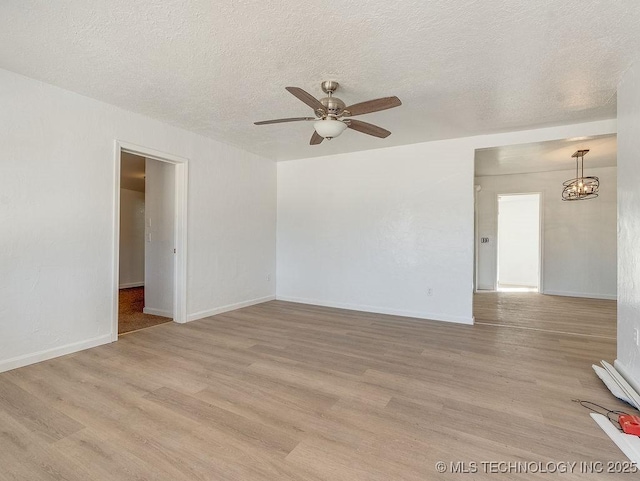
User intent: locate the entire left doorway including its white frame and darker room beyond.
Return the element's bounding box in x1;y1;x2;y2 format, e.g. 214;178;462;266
112;142;188;340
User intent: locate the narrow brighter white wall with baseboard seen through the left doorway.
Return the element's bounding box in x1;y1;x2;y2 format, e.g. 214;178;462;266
144;159;176;318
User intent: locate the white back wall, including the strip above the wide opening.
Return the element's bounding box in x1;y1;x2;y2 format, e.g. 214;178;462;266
277;121;616;323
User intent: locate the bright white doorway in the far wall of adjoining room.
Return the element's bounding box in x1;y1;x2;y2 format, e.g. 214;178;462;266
497;193;541;292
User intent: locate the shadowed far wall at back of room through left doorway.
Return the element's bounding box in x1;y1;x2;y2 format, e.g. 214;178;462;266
119;189;144;288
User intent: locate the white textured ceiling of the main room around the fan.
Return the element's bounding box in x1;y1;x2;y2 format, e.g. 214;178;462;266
0;0;640;160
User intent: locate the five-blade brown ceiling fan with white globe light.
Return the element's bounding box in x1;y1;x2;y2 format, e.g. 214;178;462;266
255;80;402;145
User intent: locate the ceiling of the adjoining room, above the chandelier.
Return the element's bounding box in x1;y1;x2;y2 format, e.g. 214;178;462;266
475;135;617;176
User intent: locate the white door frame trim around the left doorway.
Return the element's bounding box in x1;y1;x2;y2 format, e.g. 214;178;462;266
111;140;189;341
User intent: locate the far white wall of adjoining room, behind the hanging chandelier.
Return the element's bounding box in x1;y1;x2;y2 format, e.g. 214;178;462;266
476;165;617;299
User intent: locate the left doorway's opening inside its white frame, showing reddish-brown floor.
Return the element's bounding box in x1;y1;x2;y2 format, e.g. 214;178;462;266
118;152;175;334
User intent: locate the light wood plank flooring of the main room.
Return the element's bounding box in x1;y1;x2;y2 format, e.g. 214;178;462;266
0;299;633;481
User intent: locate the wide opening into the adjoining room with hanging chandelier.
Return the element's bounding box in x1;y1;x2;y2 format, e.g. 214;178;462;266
473;134;617;339
